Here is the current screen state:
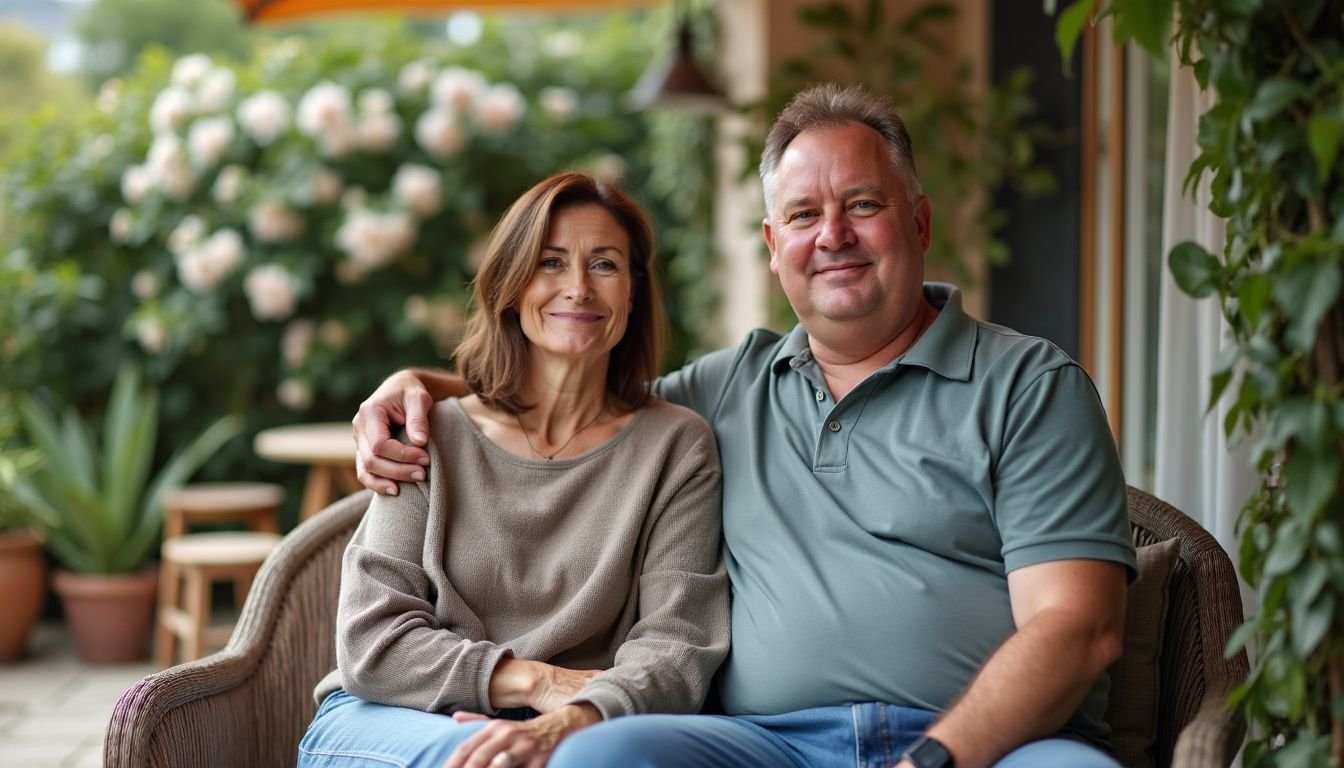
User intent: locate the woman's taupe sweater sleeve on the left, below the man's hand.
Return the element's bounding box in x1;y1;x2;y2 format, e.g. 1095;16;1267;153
336;483;508;714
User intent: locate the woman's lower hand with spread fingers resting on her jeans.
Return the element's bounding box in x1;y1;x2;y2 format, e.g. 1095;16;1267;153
444;702;602;768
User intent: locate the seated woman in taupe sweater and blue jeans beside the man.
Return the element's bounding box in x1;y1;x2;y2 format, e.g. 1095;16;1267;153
300;174;728;768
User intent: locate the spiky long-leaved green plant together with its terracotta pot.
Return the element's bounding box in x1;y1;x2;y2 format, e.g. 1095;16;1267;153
17;367;241;663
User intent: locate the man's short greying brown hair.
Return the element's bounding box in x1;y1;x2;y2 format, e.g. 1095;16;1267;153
761;82;922;213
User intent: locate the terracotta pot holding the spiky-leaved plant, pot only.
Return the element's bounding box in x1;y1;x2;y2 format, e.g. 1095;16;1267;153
51;566;159;664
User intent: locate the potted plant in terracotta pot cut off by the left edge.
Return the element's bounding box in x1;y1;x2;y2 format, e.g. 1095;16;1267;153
0;393;47;662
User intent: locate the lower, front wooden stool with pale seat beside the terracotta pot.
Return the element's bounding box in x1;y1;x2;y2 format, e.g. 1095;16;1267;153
155;531;280;667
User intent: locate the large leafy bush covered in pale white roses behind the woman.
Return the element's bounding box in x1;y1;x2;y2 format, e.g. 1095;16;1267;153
0;20;712;486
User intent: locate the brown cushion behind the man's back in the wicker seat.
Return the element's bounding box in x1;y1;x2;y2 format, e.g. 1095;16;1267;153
1106;539;1180;768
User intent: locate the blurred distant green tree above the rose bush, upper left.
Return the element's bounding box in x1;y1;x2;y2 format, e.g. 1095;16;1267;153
75;0;253;85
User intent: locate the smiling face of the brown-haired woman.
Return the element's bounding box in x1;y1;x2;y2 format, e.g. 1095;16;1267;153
517;204;633;358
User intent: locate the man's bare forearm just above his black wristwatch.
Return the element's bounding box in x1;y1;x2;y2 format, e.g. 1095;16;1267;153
927;611;1121;768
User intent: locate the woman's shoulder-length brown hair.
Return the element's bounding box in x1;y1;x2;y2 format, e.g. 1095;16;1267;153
456;174;667;413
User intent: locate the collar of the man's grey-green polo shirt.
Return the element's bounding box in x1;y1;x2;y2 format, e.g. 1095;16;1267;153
770;282;977;381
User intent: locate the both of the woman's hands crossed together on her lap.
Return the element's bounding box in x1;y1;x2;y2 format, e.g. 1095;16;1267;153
444;659;602;768
